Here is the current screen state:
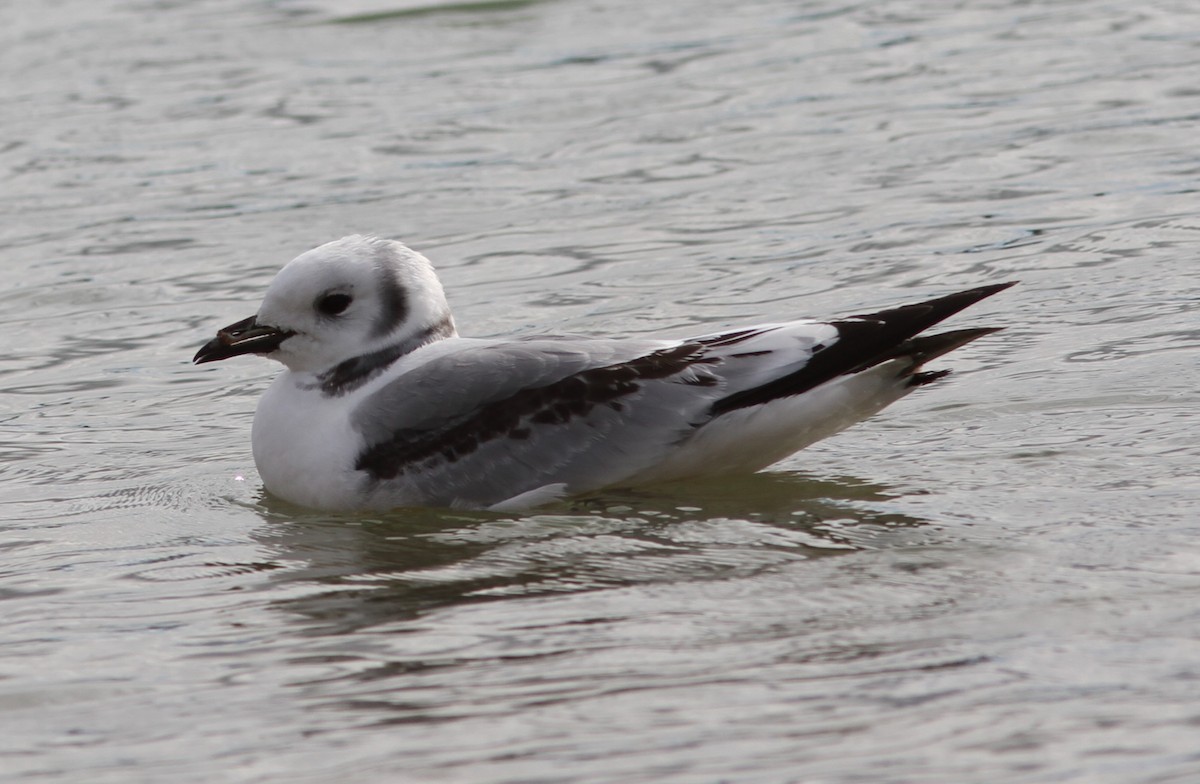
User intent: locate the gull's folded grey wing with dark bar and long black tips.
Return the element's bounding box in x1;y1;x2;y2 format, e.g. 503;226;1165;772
354;283;1012;505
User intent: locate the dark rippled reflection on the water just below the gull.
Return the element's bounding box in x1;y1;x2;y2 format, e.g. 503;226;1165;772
246;472;934;634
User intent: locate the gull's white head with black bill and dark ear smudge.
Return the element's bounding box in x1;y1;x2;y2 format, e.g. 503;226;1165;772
196;235;455;373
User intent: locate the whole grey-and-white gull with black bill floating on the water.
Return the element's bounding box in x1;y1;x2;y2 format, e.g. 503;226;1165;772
193;235;1013;510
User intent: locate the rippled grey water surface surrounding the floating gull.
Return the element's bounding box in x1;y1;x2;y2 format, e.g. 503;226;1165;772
0;0;1200;784
